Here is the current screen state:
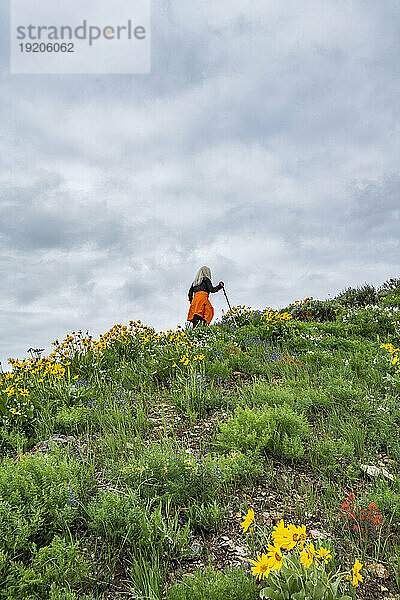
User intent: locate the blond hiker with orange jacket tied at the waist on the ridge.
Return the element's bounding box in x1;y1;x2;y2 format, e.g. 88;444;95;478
187;267;224;329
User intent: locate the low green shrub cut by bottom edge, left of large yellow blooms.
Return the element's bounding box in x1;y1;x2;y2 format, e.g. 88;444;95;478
167;569;259;600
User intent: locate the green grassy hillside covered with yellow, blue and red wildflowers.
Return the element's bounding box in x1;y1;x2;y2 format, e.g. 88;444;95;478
0;280;400;600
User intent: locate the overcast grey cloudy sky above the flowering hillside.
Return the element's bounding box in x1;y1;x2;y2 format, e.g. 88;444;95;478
0;0;400;365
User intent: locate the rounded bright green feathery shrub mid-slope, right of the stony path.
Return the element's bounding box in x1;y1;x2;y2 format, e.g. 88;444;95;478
218;404;308;460
